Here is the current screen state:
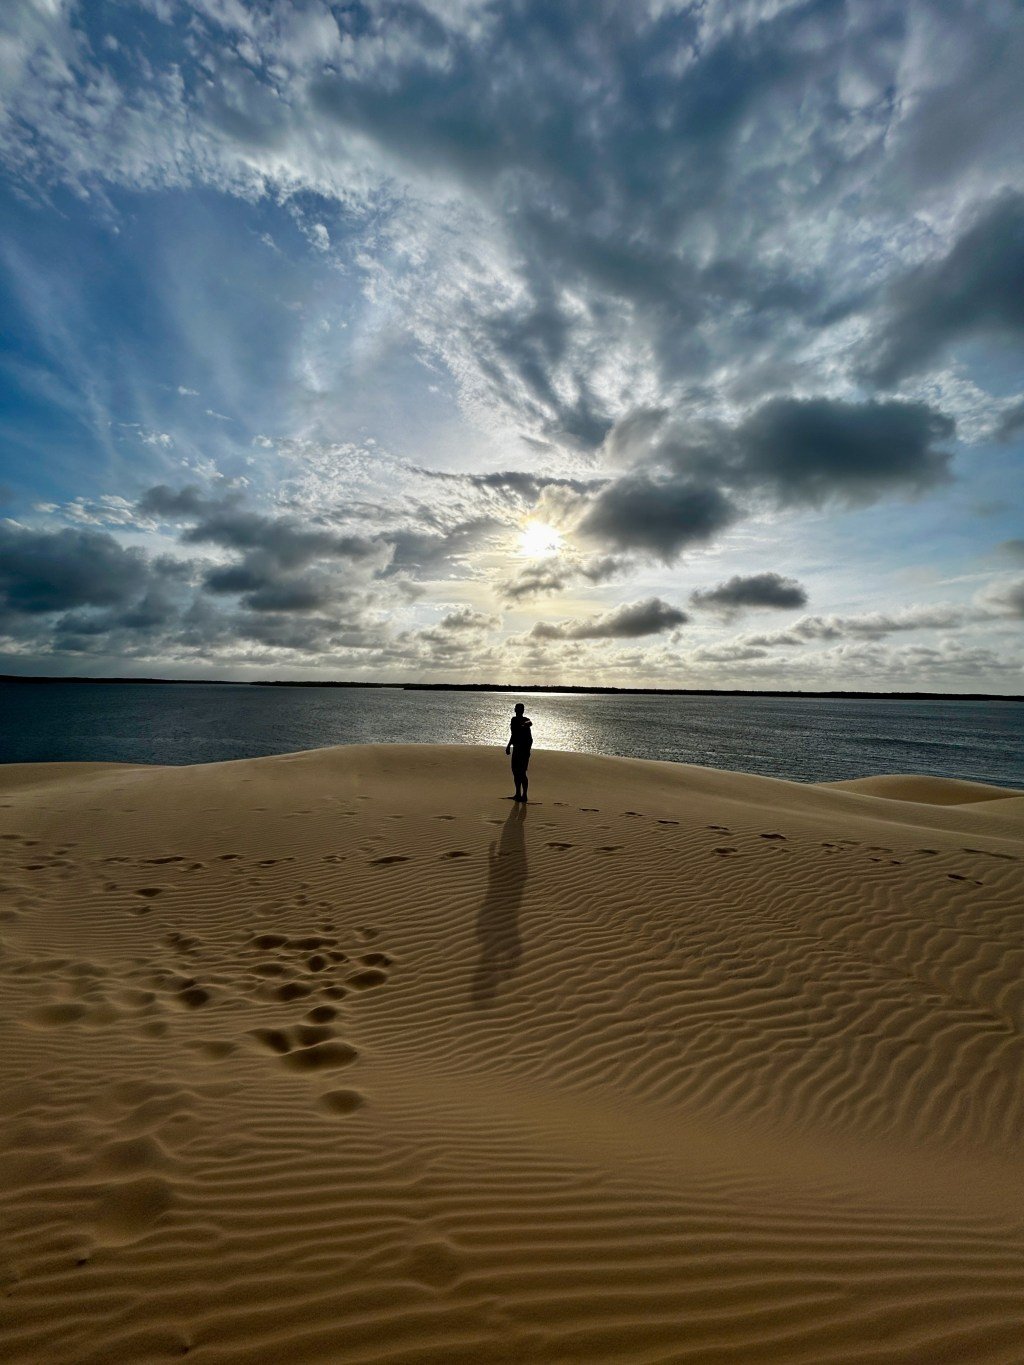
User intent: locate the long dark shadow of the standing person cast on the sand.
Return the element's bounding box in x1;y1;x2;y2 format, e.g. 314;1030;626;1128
470;804;530;1009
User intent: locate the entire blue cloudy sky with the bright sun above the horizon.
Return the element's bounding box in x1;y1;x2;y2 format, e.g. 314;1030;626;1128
0;0;1024;693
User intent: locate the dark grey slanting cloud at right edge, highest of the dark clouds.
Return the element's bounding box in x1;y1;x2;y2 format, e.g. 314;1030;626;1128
867;194;1024;388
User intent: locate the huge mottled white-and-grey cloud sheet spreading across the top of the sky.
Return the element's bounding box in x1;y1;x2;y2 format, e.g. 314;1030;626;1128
0;0;1021;464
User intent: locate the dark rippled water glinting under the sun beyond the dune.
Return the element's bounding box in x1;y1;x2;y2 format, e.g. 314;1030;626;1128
0;683;1024;788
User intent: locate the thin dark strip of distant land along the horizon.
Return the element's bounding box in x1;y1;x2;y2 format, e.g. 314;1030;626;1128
0;673;1024;702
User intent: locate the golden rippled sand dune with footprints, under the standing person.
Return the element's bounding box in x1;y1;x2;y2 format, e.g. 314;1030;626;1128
0;747;1024;1365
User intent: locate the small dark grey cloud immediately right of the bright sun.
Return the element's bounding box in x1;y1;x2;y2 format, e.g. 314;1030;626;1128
578;472;740;562
